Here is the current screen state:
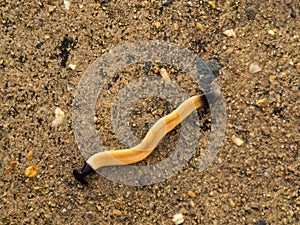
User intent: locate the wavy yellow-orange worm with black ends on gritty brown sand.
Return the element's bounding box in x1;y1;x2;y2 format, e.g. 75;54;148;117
73;91;220;184
